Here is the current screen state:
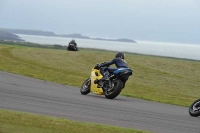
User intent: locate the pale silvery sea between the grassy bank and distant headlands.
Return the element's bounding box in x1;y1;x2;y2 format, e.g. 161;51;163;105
17;34;200;61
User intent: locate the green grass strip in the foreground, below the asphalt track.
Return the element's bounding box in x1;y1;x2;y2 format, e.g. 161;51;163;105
0;110;147;133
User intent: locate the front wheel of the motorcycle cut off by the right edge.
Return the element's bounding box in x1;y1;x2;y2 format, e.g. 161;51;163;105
189;99;200;117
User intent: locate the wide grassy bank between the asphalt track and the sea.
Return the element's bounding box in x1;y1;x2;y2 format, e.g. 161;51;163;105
0;41;200;106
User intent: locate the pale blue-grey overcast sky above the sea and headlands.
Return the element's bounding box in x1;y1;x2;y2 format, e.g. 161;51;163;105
0;0;200;44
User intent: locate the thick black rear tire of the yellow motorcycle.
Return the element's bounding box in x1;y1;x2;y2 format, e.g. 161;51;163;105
105;80;123;99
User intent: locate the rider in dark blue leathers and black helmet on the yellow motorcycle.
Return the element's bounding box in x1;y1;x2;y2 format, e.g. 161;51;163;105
95;52;128;88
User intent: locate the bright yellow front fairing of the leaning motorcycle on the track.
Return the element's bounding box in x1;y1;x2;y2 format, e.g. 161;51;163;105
90;69;103;95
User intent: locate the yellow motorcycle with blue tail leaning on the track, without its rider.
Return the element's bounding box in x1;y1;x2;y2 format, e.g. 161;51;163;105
80;64;132;99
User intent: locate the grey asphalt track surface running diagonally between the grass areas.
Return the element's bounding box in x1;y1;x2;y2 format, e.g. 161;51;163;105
0;71;200;133
